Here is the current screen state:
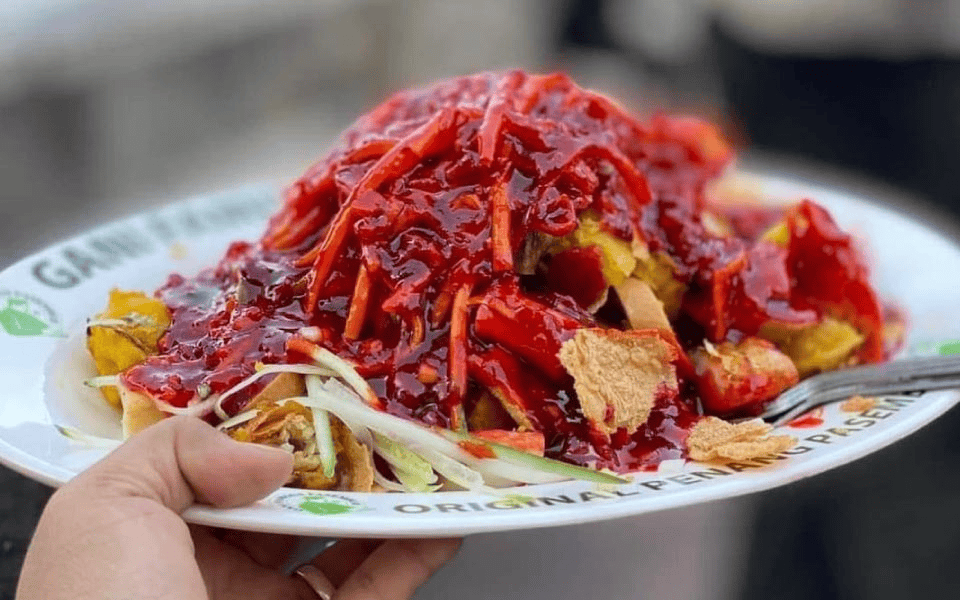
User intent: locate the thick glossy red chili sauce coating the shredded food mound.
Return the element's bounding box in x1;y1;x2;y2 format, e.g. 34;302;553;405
124;71;883;471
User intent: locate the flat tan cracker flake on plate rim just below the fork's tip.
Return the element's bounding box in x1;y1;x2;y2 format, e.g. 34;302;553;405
687;417;797;462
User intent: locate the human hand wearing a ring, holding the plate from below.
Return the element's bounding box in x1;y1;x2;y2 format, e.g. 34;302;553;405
17;417;460;600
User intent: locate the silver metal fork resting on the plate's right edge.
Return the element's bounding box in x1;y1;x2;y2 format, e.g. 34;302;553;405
759;355;960;426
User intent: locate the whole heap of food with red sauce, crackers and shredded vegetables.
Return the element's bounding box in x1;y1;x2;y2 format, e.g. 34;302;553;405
89;71;893;491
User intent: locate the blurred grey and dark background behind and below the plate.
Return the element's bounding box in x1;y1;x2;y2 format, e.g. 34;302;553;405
0;0;960;599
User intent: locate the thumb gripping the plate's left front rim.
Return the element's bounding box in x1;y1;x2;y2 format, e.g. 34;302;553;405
69;417;293;513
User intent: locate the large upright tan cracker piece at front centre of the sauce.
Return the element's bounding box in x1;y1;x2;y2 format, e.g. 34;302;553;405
560;329;679;435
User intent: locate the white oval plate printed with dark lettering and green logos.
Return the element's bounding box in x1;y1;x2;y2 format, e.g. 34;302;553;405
0;177;960;537
